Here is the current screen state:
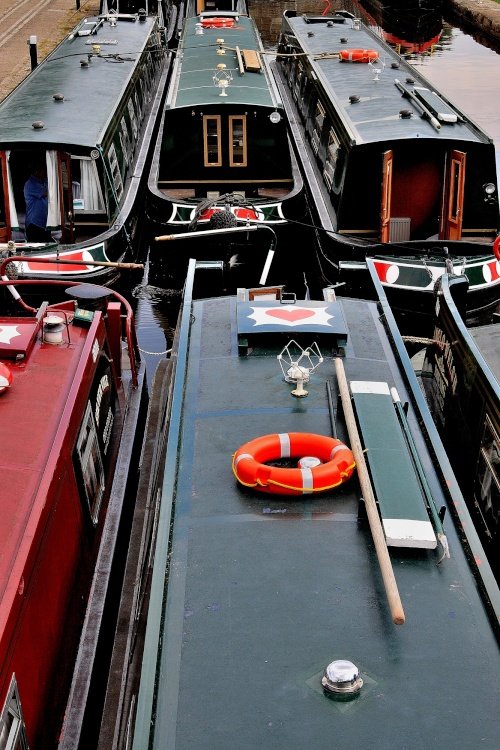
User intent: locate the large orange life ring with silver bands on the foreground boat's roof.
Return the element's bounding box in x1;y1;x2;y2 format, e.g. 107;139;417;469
233;432;356;495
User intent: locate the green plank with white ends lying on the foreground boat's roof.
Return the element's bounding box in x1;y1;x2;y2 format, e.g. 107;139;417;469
349;381;437;549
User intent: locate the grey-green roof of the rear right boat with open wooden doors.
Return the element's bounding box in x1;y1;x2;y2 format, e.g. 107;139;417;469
285;11;492;144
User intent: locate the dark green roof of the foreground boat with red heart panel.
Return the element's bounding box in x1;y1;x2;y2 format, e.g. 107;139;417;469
133;262;500;750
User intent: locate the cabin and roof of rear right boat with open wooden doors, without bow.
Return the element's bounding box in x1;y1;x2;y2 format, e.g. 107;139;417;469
278;11;498;244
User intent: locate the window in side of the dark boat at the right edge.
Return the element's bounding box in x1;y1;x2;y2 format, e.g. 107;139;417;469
475;416;500;538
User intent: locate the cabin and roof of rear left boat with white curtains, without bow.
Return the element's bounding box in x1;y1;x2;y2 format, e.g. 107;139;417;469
0;11;165;244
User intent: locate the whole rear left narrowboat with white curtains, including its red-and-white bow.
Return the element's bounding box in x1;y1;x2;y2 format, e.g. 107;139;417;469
0;3;173;285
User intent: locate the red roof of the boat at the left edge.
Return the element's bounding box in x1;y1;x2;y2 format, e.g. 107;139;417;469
0;307;102;633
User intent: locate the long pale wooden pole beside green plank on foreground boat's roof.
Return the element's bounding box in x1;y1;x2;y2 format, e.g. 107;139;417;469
335;357;405;625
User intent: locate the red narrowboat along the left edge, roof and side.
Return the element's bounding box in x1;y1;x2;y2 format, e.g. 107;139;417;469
0;256;147;750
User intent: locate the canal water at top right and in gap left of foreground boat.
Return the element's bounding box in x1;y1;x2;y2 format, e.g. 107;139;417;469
132;0;500;384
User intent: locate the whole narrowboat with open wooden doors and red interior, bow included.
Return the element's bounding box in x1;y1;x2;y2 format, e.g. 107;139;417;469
275;11;500;322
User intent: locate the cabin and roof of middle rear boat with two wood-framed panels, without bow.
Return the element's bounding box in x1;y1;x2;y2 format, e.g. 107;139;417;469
154;11;294;207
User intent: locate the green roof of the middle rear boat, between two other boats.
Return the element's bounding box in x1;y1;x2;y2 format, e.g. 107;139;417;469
166;12;281;109
